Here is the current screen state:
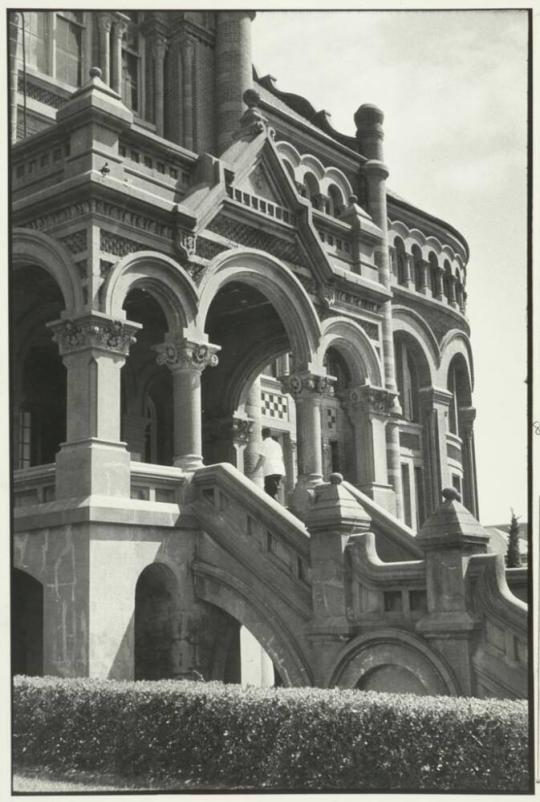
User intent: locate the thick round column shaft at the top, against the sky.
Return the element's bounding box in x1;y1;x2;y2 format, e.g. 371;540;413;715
215;10;254;154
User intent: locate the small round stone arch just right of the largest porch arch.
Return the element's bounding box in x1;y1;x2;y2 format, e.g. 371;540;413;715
318;317;383;387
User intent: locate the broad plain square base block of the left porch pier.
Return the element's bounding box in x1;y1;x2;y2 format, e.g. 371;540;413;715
56;437;130;499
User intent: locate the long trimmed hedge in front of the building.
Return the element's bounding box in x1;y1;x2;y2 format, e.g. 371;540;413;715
13;677;529;792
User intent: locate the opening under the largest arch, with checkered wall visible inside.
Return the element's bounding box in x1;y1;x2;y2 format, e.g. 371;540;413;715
202;281;296;503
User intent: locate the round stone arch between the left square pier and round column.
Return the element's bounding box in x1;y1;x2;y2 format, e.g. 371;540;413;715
103;251;197;331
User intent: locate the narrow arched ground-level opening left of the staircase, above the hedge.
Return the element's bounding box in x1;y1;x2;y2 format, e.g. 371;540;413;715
134;563;181;679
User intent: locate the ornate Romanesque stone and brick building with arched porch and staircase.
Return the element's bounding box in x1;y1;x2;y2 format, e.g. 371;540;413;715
9;11;527;696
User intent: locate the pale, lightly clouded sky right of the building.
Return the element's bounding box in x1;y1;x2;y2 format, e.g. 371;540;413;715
252;10;527;525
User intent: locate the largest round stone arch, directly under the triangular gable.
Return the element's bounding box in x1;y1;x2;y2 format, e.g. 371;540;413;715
197;250;321;369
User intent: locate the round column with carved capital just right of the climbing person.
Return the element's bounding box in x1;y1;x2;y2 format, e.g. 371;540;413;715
281;372;331;517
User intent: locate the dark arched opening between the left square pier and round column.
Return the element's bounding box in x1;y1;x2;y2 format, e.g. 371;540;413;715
122;287;173;465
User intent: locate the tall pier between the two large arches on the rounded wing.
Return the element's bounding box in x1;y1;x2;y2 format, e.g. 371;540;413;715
419;387;452;512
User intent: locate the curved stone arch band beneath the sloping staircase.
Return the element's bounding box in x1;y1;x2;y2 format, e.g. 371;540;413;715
195;564;313;686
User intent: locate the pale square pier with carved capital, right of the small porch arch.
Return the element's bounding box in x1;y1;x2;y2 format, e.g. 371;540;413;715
343;384;396;514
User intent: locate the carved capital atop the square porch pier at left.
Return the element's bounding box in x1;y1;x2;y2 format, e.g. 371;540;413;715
48;313;141;357
